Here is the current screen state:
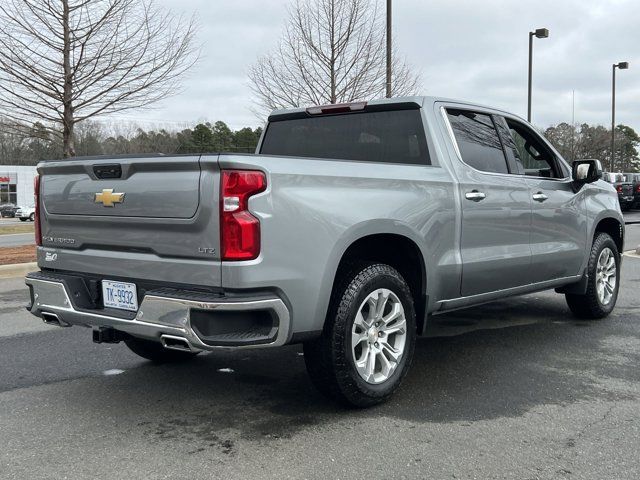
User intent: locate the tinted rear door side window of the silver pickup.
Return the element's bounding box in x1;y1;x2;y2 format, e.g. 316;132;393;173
447;109;509;173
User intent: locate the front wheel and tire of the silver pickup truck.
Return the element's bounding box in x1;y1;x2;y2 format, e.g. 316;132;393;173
565;232;620;320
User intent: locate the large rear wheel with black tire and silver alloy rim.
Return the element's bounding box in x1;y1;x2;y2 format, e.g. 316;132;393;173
304;263;416;408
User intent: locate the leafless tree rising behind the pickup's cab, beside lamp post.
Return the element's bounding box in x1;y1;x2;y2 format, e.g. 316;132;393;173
249;0;420;114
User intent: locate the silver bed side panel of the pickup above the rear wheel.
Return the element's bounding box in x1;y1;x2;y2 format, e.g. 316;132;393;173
220;155;459;333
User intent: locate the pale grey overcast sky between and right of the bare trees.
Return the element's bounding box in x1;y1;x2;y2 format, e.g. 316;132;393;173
119;0;640;132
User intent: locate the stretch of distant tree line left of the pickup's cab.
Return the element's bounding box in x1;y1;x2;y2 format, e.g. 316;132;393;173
0;121;262;165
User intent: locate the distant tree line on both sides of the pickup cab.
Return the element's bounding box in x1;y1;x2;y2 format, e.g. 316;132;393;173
0;116;640;172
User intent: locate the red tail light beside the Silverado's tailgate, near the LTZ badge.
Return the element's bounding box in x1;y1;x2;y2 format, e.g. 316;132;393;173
220;170;267;260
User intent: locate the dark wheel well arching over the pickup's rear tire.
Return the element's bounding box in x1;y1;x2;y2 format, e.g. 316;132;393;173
333;233;426;333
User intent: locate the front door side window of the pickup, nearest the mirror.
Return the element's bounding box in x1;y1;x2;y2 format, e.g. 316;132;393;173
505;118;564;178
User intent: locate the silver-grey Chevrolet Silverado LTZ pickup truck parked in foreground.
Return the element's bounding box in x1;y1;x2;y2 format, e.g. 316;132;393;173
26;97;624;407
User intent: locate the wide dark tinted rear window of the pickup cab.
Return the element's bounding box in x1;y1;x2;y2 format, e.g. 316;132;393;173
260;105;431;165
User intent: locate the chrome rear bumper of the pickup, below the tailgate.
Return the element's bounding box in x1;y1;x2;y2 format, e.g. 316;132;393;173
25;276;290;351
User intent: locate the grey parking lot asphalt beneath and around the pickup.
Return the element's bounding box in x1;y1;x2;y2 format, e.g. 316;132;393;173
0;226;640;479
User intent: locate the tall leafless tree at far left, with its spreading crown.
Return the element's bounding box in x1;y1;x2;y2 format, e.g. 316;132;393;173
0;0;197;157
